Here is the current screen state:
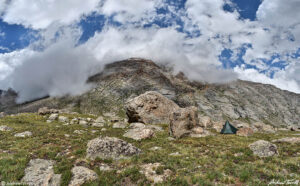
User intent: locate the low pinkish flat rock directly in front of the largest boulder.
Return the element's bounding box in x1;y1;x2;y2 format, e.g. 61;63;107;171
123;128;154;141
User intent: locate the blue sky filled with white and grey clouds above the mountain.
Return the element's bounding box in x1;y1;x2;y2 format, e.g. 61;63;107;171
0;0;300;102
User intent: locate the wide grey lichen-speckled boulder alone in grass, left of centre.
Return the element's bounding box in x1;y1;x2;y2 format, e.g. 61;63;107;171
87;137;141;160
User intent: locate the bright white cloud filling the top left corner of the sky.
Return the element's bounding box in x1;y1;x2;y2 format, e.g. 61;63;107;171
0;0;99;29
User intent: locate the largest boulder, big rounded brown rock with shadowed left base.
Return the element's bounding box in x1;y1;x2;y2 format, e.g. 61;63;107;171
125;91;180;124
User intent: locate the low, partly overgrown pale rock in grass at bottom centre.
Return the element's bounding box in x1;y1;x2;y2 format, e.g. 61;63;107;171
141;163;172;183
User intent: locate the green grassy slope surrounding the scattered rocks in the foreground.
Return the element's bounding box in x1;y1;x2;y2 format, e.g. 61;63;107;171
0;114;300;185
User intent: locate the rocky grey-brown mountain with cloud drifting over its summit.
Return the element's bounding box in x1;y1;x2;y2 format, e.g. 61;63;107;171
0;58;300;127
